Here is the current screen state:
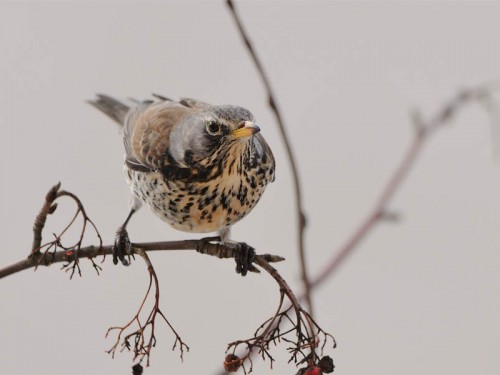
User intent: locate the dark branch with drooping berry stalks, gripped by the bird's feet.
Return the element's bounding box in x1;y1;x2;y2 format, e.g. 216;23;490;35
0;184;335;373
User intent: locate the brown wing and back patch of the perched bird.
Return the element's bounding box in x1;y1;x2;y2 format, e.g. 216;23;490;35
123;101;195;171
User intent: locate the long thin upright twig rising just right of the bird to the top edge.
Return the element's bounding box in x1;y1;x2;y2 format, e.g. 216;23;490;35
226;0;313;315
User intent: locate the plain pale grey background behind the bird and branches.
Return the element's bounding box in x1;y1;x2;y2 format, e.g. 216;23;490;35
0;1;500;375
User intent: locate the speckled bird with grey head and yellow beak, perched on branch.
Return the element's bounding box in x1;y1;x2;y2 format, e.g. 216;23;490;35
88;94;276;276
